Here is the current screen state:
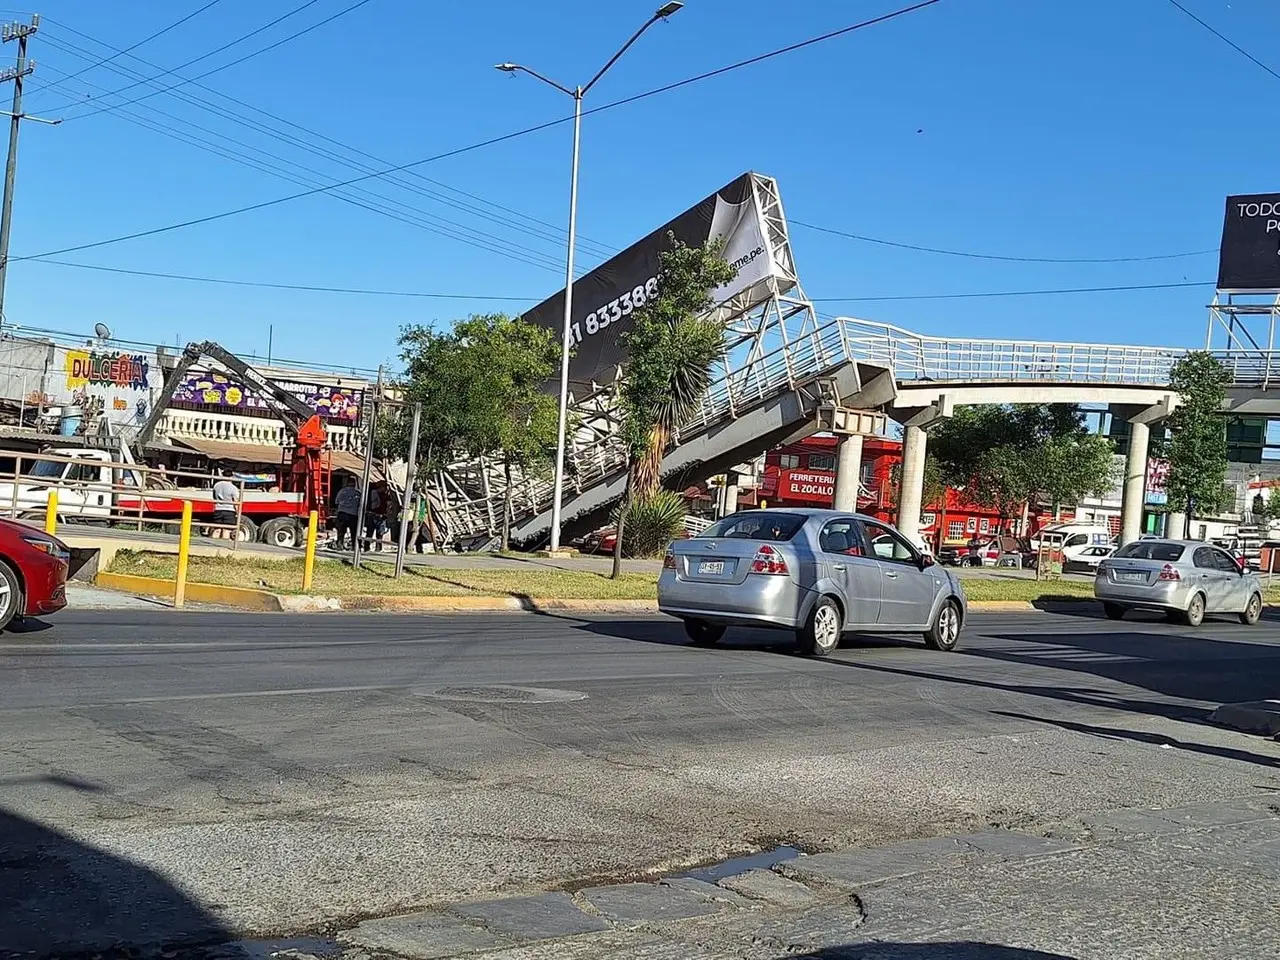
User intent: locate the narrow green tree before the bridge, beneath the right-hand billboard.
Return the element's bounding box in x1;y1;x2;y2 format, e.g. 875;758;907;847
1156;351;1231;536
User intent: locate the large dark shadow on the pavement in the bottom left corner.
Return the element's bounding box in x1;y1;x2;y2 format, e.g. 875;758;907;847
0;809;229;960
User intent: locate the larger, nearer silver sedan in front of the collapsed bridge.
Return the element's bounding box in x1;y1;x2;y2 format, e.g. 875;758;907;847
658;509;968;657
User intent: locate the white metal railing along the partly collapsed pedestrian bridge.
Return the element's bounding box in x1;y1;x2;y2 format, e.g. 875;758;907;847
448;317;1280;534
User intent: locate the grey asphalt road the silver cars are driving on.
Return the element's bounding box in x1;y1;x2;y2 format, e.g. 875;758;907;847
0;609;1280;954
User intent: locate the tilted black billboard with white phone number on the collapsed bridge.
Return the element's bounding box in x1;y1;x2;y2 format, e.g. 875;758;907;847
525;173;782;384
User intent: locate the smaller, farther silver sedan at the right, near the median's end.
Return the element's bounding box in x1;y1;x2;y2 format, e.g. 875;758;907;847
1093;539;1262;627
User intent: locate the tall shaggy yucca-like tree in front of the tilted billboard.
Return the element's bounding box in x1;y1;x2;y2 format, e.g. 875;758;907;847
613;234;736;576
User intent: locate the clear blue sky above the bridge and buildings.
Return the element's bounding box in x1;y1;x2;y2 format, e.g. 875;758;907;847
0;0;1280;366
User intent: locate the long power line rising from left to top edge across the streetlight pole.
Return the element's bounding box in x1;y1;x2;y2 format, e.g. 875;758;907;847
10;0;941;260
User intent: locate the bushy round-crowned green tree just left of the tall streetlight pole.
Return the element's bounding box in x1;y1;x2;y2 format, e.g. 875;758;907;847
398;314;561;549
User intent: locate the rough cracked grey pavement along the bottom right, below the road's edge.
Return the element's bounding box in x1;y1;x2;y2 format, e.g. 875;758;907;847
238;796;1280;960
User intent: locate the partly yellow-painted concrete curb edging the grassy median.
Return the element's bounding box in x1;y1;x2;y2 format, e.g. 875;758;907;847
93;573;1094;613
